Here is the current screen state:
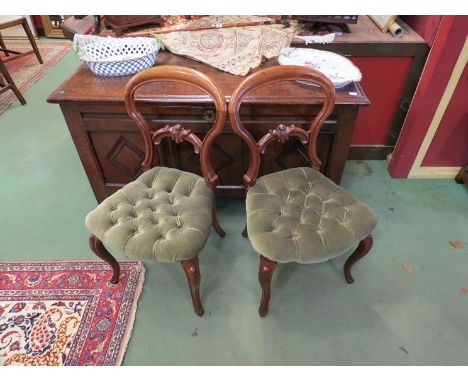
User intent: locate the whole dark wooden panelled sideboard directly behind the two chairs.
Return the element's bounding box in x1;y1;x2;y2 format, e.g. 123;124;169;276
48;52;373;202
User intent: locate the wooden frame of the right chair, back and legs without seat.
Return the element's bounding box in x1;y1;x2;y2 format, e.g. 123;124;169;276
229;65;372;317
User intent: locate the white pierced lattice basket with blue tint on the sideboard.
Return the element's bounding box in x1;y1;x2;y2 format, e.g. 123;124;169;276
73;34;161;76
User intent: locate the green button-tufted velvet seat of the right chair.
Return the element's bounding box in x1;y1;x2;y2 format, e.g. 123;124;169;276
247;167;377;263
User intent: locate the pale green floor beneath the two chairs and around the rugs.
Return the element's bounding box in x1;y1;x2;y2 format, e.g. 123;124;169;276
0;46;468;365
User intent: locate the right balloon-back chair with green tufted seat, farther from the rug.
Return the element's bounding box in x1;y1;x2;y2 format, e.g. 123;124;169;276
229;66;377;317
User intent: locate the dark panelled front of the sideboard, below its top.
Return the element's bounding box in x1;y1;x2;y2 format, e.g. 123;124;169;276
82;106;336;196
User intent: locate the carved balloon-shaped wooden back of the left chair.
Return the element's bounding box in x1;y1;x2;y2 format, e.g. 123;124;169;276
125;65;227;189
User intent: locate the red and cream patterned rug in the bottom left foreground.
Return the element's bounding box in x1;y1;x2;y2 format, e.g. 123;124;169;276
0;260;145;366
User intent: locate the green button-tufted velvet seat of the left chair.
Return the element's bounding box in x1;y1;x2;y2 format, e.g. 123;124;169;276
85;167;213;262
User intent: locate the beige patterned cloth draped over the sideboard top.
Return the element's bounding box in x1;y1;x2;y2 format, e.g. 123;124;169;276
159;25;295;76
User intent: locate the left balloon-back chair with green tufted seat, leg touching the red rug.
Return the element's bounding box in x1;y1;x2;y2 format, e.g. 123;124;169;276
85;66;227;316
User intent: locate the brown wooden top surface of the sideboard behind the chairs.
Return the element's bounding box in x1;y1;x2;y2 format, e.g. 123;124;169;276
47;51;370;105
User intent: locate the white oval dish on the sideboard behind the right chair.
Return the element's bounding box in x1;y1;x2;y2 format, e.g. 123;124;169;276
278;48;362;89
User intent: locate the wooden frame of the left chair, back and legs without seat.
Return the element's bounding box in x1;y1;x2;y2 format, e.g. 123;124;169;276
90;65;227;316
